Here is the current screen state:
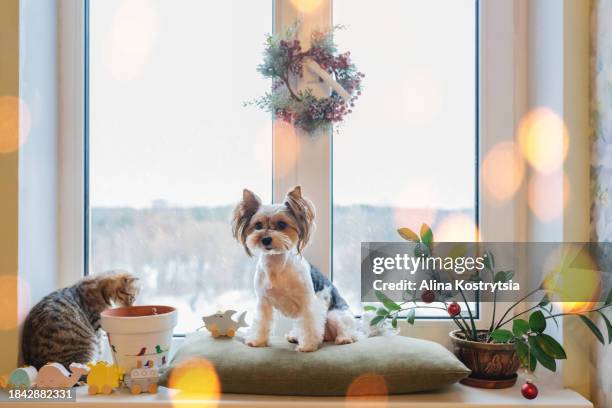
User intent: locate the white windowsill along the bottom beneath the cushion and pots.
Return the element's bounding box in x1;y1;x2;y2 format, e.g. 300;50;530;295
0;384;593;408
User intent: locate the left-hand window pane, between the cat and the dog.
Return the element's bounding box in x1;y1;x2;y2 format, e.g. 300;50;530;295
89;0;272;333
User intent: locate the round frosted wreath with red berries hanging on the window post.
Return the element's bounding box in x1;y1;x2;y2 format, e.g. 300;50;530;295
247;24;365;133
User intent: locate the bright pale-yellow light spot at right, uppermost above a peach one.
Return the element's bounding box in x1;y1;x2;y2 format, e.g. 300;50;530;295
518;108;569;173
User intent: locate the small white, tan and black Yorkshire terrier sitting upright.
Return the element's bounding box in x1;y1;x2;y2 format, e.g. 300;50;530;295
232;186;358;352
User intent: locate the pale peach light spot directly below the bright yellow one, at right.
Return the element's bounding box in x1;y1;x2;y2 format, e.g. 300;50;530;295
527;171;570;222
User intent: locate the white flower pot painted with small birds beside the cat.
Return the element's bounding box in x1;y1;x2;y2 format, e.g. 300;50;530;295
101;305;177;372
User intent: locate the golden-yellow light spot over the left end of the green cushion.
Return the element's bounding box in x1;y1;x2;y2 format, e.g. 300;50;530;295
168;358;221;408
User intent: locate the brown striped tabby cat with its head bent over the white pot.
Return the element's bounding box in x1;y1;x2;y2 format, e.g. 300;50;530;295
21;271;138;369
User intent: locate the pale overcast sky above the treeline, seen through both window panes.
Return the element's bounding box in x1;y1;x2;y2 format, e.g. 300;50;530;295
90;0;475;208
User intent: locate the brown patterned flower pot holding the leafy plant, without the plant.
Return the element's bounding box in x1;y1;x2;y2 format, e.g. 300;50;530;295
450;330;520;388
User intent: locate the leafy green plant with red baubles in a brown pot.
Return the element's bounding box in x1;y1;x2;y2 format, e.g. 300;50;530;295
364;224;612;395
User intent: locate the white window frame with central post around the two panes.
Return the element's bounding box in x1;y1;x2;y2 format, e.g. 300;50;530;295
58;0;526;345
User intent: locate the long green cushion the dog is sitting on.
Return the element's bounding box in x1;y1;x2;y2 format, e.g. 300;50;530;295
161;332;470;396
